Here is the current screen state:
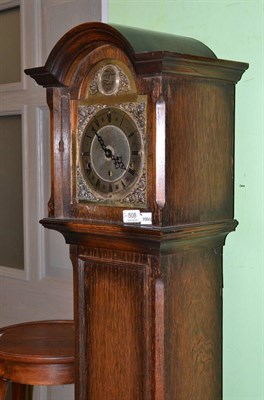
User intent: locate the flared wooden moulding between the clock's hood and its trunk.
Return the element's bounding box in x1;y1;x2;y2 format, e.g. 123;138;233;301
40;218;238;255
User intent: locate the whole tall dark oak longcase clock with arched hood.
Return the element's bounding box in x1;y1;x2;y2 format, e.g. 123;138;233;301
26;23;247;400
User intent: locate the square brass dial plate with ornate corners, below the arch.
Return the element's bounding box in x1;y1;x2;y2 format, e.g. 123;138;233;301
77;102;146;206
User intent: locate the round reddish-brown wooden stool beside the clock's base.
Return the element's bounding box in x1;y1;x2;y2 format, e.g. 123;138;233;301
0;321;74;400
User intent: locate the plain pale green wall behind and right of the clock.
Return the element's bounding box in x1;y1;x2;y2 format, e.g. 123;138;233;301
108;0;264;400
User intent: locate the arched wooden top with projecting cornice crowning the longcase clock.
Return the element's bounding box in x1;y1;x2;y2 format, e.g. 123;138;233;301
25;22;247;87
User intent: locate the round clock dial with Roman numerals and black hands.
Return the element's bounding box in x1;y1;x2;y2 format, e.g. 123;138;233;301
79;107;143;198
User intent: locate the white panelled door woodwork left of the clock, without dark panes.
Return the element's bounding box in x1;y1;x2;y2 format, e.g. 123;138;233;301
0;0;107;400
